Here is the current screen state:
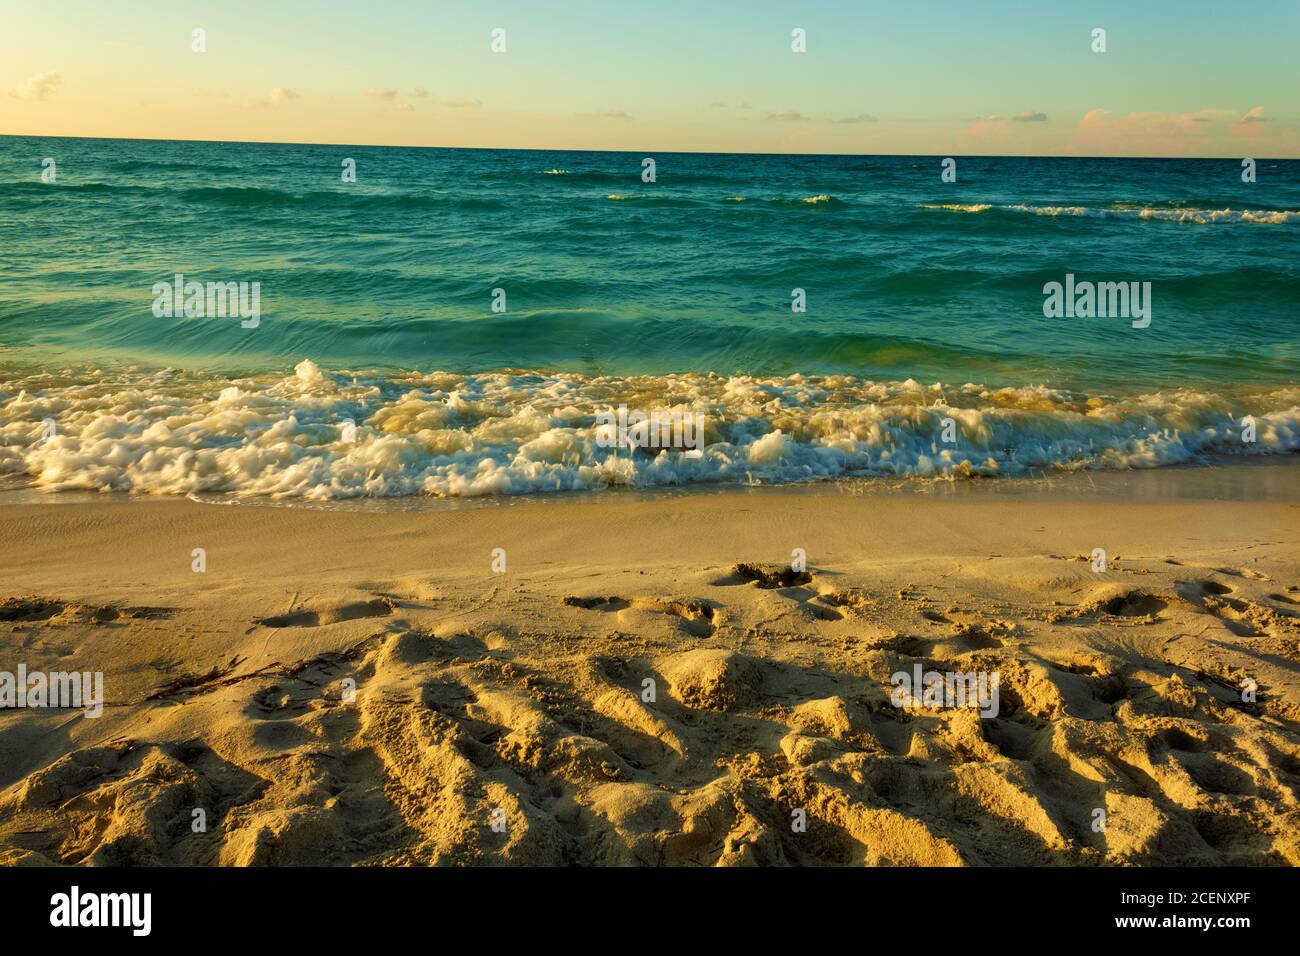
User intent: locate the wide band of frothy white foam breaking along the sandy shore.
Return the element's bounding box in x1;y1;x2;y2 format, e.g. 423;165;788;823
0;362;1300;499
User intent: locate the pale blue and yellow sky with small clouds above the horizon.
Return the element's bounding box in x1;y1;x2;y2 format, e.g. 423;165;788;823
0;0;1300;157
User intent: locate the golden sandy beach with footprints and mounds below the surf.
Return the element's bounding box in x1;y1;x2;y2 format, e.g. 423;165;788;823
0;464;1300;865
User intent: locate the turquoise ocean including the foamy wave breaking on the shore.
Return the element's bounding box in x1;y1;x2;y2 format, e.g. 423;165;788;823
0;137;1300;499
